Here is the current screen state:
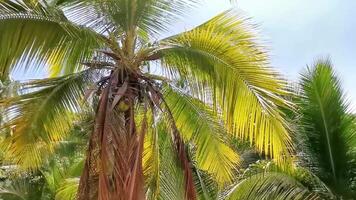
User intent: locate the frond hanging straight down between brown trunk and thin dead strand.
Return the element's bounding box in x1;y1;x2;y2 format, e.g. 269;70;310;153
143;119;185;200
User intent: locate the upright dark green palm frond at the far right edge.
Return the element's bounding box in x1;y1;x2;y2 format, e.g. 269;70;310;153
299;59;356;199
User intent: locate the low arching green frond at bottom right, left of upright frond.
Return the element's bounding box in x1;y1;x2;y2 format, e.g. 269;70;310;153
222;160;332;200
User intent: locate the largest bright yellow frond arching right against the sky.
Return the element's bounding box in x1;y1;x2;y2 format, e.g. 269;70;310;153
157;10;292;161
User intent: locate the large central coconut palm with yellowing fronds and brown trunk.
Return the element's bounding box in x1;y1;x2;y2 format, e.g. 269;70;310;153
0;0;292;200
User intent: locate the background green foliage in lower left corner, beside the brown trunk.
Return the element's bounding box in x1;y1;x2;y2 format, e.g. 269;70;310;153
0;113;90;200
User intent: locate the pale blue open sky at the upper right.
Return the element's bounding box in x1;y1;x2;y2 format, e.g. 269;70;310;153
170;0;356;109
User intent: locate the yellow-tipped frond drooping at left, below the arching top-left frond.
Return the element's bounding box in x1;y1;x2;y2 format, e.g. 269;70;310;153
0;70;94;170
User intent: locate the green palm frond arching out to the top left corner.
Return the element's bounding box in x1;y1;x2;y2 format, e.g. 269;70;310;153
0;1;103;77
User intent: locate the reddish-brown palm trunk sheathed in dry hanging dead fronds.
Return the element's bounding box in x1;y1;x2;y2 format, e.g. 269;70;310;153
78;73;147;200
